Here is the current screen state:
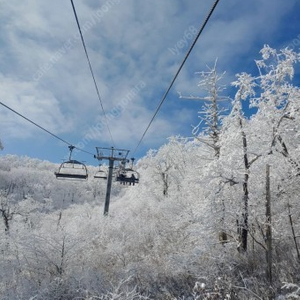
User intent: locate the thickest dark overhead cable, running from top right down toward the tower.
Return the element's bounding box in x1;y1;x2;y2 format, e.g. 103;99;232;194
133;0;220;154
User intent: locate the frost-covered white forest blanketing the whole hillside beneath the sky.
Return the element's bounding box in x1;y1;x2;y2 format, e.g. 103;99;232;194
0;46;300;300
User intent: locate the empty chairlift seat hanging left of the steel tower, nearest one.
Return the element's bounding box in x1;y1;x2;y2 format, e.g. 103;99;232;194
54;145;88;180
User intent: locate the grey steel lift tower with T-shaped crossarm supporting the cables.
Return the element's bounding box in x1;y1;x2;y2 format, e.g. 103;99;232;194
95;147;129;216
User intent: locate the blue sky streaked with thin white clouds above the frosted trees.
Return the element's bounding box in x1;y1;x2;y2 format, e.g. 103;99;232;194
0;0;300;165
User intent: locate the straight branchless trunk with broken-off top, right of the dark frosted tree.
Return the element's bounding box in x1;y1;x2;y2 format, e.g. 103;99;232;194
266;165;272;284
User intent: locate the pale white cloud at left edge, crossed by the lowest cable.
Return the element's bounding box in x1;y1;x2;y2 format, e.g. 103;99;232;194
0;73;73;139
